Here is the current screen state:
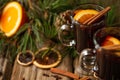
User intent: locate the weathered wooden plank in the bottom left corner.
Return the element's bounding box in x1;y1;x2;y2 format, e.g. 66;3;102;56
0;55;12;80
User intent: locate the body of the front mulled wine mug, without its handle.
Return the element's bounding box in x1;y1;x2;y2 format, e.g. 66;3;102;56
93;27;120;80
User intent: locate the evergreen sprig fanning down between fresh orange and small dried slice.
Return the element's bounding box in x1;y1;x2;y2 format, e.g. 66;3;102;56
12;20;42;53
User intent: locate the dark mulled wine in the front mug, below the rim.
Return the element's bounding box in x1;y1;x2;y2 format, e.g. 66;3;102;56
96;45;120;80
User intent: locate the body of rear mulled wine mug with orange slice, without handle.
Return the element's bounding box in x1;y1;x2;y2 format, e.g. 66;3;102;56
73;4;106;52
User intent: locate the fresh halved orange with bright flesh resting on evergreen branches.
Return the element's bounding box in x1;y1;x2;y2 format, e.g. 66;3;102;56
0;1;26;37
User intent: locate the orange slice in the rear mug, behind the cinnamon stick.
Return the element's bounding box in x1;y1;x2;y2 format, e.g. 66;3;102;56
74;9;98;23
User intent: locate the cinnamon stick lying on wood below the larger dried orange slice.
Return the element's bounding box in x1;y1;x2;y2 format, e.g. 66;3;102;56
50;68;80;80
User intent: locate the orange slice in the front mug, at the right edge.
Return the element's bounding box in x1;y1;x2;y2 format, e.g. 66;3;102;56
102;36;120;46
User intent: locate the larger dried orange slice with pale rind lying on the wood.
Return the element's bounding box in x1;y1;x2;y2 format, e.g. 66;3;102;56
33;47;62;69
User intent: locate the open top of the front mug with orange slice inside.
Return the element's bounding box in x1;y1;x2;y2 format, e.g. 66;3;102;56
93;27;120;48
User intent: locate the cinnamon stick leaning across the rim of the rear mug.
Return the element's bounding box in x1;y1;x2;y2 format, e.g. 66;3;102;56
83;6;111;25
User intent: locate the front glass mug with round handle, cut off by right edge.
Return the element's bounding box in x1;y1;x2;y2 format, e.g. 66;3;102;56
79;27;120;80
